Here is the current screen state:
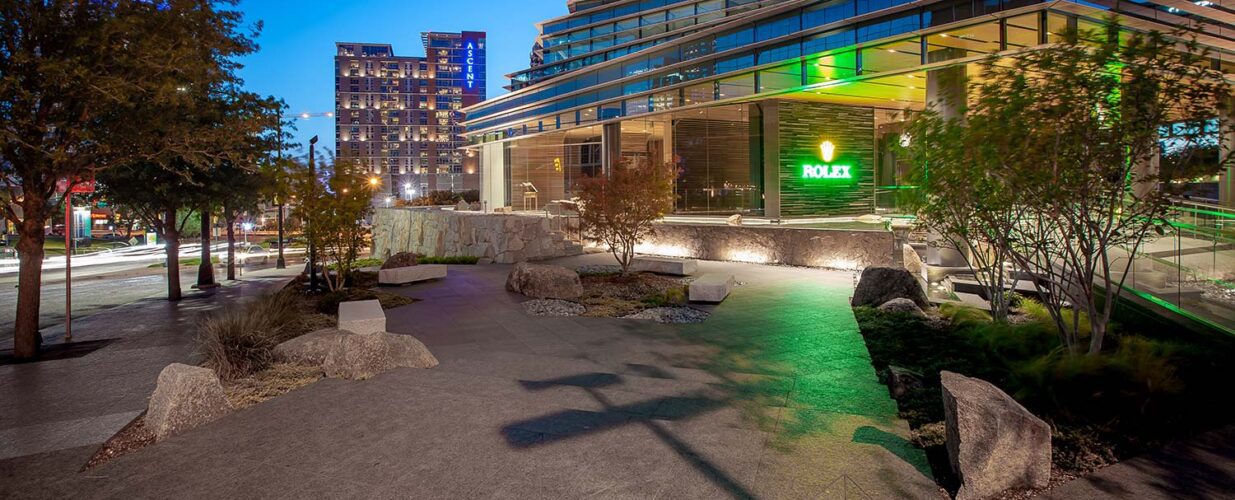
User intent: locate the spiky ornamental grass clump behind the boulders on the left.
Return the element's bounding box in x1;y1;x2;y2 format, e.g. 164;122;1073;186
196;291;300;380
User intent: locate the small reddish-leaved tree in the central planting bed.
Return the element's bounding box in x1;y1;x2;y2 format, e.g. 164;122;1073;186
579;162;673;274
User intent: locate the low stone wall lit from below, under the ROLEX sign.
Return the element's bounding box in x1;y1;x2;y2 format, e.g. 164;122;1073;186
636;223;900;269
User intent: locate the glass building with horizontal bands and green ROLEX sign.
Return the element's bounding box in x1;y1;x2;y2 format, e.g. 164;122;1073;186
464;0;1235;219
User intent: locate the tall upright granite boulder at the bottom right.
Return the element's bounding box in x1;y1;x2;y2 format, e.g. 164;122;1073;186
940;370;1051;500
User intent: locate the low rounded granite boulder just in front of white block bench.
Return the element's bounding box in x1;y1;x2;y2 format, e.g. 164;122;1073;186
321;332;437;380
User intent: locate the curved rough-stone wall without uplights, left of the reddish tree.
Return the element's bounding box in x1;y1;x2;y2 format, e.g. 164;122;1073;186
373;209;583;263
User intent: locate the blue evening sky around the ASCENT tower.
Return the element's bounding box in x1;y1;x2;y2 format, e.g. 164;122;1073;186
232;0;567;149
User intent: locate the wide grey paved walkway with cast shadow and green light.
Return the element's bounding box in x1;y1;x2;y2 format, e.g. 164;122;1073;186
0;256;939;499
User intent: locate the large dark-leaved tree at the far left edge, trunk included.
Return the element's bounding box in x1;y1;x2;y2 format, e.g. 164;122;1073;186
0;0;259;358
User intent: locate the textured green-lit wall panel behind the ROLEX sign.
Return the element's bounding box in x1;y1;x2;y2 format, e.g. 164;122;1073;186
778;100;874;217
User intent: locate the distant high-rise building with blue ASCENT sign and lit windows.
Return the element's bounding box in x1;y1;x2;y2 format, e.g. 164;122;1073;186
335;31;485;204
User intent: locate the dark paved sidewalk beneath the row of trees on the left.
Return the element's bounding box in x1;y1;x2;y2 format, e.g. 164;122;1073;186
0;269;296;461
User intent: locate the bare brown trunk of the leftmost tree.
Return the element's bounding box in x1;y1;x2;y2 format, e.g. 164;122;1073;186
12;204;47;359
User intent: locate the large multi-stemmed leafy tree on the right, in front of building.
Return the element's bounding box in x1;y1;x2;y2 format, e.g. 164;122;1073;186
916;19;1231;354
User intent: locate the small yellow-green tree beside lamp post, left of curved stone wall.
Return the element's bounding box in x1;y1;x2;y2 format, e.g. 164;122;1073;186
294;153;373;290
